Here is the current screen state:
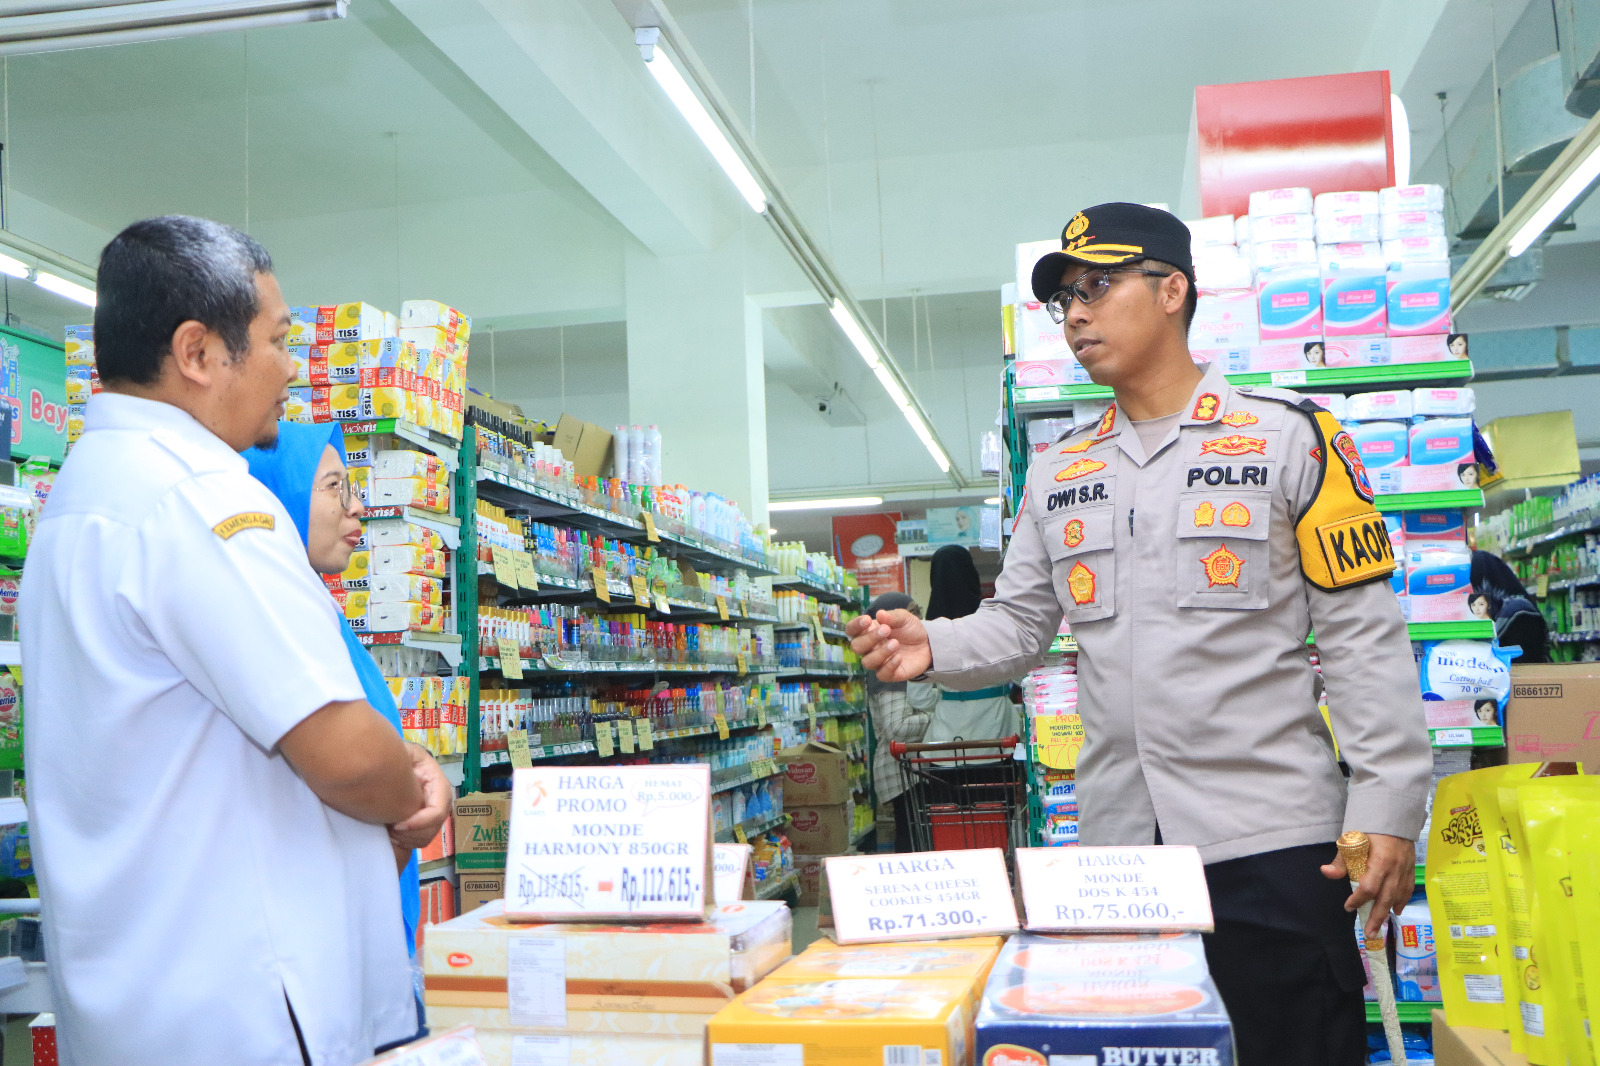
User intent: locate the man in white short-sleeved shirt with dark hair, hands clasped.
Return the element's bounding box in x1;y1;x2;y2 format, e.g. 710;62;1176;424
19;216;450;1066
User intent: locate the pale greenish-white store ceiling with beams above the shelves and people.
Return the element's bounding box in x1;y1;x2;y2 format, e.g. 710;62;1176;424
0;0;1600;515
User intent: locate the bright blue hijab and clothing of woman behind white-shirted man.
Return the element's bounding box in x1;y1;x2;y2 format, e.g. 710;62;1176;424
245;423;422;957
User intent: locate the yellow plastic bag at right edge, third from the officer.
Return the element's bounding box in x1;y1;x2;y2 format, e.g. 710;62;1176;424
1517;778;1600;1066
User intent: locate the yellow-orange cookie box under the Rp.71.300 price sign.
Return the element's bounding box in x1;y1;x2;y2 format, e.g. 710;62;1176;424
706;978;973;1066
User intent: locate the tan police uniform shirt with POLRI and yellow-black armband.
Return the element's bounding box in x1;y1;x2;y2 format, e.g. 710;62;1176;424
928;356;1432;863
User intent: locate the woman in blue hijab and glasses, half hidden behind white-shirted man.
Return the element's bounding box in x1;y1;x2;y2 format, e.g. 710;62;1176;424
245;423;422;1030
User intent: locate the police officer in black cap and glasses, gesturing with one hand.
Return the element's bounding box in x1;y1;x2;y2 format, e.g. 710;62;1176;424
850;203;1432;1066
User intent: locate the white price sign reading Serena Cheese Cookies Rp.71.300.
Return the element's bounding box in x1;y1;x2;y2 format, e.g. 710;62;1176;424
824;848;1016;944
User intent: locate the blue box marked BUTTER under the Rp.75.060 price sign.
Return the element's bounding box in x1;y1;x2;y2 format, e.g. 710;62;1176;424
966;933;1234;1066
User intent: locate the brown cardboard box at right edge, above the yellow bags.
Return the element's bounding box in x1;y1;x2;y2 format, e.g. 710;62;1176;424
1506;663;1600;773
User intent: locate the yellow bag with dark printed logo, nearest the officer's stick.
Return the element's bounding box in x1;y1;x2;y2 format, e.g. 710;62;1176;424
1426;763;1568;1029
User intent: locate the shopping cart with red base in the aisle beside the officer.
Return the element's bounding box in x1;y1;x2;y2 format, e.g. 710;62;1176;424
890;736;1027;864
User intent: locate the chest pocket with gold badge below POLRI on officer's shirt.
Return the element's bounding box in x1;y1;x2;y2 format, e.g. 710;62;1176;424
1173;490;1272;610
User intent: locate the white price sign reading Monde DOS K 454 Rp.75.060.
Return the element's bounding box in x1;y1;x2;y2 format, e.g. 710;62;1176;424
1016;845;1214;933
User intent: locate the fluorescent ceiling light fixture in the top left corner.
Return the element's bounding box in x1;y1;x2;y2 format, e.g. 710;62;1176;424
0;0;349;56
